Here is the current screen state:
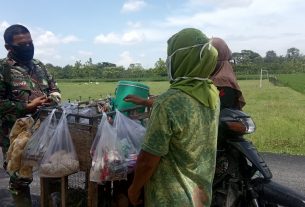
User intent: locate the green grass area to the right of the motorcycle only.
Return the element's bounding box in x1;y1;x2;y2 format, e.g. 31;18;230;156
239;81;305;155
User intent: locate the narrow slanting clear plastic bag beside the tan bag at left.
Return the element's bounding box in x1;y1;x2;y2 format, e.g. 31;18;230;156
22;109;58;167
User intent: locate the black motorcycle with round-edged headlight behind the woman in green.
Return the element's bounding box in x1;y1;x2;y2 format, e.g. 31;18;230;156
211;108;305;207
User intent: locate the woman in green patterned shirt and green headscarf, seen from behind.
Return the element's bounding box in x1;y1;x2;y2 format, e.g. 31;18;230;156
128;28;220;207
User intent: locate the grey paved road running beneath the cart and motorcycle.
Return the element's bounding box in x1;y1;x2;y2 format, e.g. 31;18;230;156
0;151;305;207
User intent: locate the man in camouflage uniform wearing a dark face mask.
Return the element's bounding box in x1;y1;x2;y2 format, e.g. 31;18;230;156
0;25;60;207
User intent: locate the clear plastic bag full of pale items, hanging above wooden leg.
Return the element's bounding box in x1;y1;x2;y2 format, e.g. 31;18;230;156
39;111;79;177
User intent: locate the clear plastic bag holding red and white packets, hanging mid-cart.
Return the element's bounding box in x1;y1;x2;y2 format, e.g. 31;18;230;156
90;113;127;183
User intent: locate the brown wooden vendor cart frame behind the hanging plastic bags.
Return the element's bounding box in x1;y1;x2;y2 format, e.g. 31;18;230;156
39;106;149;207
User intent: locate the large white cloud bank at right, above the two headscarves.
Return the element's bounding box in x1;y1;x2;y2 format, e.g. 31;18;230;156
158;0;305;55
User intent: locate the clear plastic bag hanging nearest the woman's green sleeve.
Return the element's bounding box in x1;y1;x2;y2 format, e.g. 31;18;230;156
114;110;146;171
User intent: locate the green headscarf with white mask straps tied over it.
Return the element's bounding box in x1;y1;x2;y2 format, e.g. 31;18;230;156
167;28;219;109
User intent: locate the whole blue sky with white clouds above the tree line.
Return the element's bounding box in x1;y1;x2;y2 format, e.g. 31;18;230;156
0;0;305;68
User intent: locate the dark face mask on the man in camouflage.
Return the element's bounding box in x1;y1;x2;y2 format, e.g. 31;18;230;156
10;43;34;62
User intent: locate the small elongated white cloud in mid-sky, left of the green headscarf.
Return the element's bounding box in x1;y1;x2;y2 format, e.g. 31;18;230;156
94;30;144;44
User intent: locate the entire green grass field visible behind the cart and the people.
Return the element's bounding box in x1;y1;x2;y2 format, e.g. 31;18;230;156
59;79;305;155
